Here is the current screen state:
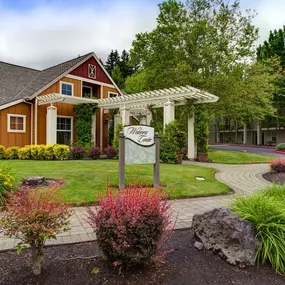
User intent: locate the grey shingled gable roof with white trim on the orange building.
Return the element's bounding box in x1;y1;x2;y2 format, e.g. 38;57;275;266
0;52;121;109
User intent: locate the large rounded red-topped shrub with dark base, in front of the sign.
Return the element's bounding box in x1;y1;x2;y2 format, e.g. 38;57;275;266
87;187;173;268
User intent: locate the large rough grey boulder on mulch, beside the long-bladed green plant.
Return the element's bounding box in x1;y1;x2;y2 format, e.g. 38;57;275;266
192;208;259;268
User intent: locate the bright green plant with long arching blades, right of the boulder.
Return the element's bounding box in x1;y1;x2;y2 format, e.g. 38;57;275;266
230;185;285;274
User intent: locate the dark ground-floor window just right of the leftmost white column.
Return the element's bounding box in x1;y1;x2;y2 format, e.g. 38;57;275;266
56;117;73;145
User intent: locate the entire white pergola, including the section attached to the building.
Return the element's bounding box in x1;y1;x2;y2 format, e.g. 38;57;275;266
37;86;219;159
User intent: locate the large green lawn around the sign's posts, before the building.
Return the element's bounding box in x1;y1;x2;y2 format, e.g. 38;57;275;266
3;160;229;205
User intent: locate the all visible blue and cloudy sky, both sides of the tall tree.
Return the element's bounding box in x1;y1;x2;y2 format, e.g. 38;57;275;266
0;0;285;69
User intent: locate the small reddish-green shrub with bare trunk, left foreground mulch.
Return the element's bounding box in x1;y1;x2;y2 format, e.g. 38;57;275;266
0;189;71;275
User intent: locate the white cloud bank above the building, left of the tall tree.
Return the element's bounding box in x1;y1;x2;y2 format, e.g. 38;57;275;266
0;1;158;68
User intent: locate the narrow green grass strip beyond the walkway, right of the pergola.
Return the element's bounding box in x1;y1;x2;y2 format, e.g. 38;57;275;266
209;149;276;164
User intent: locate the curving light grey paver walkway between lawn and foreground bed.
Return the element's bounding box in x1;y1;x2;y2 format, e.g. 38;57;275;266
0;161;270;251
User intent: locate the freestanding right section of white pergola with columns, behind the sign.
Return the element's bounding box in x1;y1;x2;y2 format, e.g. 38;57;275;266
98;86;219;159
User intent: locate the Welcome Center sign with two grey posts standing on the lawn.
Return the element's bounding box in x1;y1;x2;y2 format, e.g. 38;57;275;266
119;125;160;189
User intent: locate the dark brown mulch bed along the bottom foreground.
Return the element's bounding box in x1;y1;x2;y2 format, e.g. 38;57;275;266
0;229;285;285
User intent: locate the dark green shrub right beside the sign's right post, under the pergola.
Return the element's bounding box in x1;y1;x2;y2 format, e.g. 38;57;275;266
160;133;177;164
